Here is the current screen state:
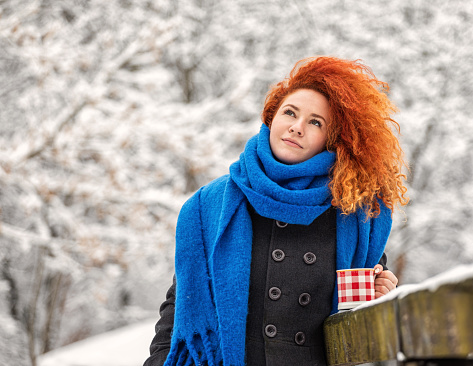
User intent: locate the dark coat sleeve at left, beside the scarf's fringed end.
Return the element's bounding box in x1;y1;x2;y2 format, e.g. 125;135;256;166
143;276;176;366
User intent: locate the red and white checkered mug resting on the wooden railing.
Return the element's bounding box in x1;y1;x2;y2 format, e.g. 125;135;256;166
337;268;375;310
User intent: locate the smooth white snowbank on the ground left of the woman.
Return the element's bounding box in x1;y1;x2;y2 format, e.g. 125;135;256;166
38;319;156;366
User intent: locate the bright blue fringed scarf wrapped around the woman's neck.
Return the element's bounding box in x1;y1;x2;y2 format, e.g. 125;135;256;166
165;125;391;366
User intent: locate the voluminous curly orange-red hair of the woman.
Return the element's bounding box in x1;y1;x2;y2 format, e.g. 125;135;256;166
262;57;409;217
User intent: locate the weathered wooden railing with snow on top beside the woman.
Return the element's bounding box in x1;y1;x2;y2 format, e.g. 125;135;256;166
324;266;473;366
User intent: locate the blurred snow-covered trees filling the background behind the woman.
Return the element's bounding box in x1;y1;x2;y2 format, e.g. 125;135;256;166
0;0;473;365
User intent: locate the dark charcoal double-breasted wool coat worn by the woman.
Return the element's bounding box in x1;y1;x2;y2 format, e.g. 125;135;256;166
144;206;386;366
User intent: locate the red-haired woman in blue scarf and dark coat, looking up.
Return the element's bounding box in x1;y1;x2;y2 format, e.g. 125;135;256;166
145;57;407;366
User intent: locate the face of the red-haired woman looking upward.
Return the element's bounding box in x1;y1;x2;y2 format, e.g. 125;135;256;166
269;89;329;164
